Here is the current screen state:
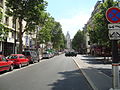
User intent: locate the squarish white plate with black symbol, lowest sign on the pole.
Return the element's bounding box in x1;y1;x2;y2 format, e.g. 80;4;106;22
109;29;120;40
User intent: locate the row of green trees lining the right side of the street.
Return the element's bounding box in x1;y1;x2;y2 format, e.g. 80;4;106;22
72;0;118;50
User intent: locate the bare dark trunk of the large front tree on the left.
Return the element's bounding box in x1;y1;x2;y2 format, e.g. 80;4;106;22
18;18;23;53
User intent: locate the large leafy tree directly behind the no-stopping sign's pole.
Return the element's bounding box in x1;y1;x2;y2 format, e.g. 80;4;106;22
88;0;116;45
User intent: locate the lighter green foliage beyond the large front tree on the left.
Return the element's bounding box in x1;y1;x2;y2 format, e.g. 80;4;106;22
39;16;65;50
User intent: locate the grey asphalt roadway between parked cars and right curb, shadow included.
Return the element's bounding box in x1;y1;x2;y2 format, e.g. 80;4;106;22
0;55;92;90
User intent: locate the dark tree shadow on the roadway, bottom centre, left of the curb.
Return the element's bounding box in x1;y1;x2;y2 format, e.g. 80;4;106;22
48;70;92;90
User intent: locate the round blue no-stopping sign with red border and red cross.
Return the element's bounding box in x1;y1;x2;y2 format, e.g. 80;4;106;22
106;7;120;23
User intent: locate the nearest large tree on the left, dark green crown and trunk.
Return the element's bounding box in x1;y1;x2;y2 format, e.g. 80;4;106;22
6;0;47;53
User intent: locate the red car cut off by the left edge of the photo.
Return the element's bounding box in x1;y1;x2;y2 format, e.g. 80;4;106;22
0;55;14;71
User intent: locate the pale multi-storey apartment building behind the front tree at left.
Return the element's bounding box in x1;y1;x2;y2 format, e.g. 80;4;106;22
0;0;34;56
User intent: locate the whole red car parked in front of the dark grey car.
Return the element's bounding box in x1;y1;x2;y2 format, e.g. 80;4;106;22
8;54;29;68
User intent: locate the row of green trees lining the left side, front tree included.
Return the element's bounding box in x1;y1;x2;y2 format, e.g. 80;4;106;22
0;0;65;53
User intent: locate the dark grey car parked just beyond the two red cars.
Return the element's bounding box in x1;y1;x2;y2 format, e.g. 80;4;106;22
22;50;40;63
